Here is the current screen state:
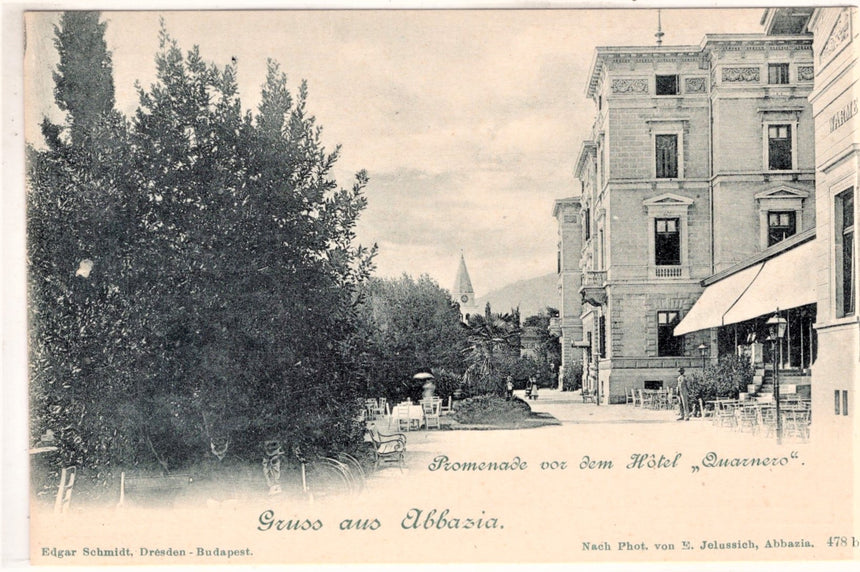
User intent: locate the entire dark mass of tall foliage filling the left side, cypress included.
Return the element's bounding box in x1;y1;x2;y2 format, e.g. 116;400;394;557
27;14;375;488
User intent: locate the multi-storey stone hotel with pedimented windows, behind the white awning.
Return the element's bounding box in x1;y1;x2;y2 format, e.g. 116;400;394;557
556;27;816;403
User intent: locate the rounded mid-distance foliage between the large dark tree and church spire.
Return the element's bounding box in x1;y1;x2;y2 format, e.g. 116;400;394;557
353;274;466;400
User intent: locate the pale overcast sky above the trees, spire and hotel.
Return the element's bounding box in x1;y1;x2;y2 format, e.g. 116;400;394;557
25;9;762;296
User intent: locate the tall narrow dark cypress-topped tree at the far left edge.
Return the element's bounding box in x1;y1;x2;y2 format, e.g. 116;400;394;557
27;12;137;488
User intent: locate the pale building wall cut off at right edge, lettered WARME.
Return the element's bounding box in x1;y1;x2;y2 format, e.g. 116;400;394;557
808;7;860;470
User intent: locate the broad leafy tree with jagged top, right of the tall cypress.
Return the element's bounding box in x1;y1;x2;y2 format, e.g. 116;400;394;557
133;33;372;464
